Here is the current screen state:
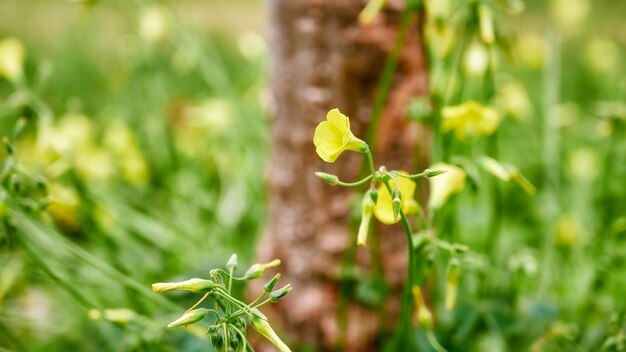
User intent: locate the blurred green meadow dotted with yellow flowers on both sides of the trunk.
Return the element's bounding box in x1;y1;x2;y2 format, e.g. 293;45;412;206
0;0;626;351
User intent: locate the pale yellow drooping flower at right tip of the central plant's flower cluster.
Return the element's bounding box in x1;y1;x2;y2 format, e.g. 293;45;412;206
428;163;465;209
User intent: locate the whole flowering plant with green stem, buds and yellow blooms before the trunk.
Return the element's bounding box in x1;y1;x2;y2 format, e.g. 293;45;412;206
313;109;467;351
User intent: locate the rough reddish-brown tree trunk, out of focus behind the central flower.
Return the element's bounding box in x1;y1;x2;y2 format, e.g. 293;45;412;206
255;0;427;351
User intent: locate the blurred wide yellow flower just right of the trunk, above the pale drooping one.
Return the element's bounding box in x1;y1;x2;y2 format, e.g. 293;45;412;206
441;100;500;140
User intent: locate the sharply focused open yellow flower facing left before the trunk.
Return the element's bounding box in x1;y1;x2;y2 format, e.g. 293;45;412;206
313;109;368;163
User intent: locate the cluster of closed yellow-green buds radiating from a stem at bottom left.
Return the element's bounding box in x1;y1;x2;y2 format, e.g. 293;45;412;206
152;254;292;352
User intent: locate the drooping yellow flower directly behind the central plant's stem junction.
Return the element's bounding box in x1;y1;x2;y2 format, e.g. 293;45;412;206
374;171;416;225
